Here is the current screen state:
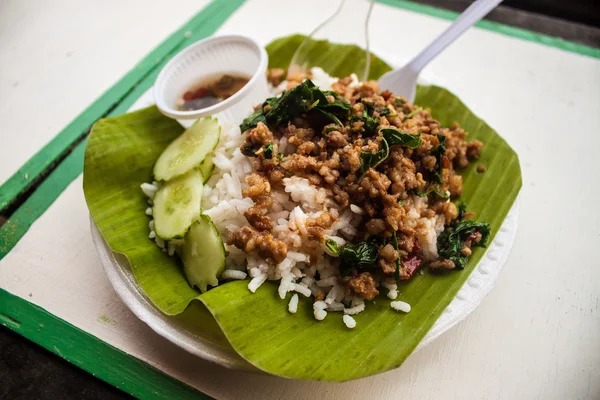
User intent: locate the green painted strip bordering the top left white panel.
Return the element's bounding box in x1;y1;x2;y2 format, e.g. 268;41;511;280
0;0;244;212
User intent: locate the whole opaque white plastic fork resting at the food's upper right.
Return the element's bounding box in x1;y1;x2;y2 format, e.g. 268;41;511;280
378;0;503;102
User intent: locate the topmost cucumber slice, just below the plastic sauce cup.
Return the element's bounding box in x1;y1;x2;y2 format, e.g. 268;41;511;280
154;117;221;181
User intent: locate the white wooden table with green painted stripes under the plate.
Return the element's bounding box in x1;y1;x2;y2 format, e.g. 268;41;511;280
0;0;600;399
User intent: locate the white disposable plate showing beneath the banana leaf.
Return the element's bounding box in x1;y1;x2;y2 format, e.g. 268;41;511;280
90;57;519;371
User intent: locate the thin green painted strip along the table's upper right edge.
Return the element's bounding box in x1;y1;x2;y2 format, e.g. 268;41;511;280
377;0;600;58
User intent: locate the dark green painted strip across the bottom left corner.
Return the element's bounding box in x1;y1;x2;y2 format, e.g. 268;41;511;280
0;290;212;400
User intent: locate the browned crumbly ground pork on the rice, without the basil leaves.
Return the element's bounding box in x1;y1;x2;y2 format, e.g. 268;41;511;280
229;70;483;300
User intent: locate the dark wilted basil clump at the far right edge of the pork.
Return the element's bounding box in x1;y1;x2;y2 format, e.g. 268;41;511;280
437;219;490;269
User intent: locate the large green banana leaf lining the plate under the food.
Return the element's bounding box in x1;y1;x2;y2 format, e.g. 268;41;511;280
84;35;521;381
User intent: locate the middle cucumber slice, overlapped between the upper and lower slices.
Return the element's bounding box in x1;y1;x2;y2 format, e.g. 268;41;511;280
152;169;203;240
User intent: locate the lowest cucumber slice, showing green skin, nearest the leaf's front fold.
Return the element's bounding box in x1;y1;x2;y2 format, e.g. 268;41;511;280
181;215;225;292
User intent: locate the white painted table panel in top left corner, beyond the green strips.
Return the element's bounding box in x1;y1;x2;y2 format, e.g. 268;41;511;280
0;0;209;184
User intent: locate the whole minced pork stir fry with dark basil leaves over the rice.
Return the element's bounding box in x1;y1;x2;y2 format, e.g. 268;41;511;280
228;70;489;301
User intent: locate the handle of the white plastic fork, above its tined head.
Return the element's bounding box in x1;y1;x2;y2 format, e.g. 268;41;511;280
407;0;503;73
